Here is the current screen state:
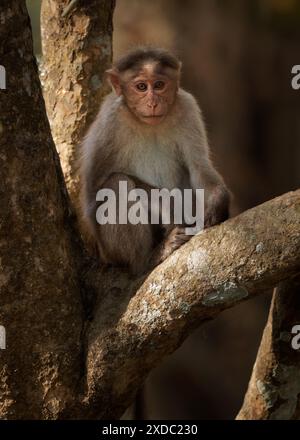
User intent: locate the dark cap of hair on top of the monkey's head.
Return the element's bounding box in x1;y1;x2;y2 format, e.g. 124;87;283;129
114;46;181;72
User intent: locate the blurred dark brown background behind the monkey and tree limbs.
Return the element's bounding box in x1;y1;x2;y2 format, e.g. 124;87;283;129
27;0;300;419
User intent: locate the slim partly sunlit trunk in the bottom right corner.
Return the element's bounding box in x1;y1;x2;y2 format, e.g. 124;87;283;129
237;276;300;420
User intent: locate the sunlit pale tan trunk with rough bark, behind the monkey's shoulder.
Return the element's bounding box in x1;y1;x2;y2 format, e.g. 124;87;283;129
41;0;115;202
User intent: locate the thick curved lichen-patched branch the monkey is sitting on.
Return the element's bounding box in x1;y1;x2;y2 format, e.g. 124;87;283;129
73;190;300;419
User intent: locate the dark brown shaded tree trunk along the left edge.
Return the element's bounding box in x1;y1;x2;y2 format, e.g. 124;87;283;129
0;0;82;418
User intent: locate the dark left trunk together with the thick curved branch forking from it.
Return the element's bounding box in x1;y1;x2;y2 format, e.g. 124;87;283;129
0;0;300;419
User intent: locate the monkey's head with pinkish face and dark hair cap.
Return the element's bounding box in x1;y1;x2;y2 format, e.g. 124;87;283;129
107;47;181;125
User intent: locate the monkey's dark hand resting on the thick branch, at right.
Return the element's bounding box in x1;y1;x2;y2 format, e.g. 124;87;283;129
204;185;229;229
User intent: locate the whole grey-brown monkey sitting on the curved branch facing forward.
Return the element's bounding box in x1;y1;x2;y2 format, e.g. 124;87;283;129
80;47;229;274
